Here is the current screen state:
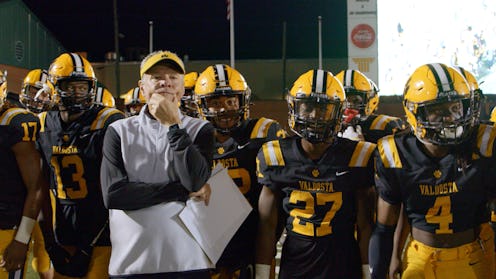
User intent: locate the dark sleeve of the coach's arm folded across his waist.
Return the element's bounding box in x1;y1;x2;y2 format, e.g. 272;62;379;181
100;126;188;210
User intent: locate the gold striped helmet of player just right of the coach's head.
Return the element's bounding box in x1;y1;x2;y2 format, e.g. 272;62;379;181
194;64;251;133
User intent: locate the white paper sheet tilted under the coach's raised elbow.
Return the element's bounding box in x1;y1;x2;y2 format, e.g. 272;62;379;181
179;164;252;264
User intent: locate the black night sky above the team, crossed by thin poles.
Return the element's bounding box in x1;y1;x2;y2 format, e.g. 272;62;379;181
23;0;347;62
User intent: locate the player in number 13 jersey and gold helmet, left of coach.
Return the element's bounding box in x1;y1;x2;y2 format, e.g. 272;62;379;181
39;53;124;278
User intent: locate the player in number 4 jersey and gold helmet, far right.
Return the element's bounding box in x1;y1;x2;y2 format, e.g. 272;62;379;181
369;63;496;278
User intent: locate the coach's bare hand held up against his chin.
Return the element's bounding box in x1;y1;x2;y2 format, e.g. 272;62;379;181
148;94;181;126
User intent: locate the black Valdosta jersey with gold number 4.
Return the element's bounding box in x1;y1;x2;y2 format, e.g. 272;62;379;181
375;125;496;234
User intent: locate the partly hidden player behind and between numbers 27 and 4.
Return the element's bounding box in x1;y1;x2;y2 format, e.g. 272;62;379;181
336;70;405;143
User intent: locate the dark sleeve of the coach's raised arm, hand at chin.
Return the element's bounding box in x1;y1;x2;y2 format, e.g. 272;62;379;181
167;123;214;192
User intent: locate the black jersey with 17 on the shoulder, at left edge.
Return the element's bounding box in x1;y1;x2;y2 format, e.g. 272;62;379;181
0;108;40;229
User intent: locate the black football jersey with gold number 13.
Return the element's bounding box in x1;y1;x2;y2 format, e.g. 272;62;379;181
39;106;124;245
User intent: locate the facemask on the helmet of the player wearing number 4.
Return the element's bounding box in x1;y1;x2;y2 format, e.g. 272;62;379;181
405;97;474;145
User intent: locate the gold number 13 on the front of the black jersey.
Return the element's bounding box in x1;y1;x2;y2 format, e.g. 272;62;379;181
51;155;88;200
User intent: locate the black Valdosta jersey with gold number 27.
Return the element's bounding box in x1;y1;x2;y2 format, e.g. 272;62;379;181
257;137;375;239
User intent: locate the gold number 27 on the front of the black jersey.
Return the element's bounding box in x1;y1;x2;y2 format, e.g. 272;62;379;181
289;191;343;236
